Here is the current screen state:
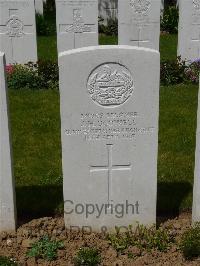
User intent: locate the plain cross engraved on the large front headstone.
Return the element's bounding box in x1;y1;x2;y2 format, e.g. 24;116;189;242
90;144;131;204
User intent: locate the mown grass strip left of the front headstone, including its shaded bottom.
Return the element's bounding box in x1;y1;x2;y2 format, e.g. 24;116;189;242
9;90;62;216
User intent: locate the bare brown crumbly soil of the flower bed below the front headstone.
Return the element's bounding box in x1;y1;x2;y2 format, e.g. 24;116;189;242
0;213;200;266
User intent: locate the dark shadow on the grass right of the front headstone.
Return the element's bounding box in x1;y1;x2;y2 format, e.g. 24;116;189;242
157;182;192;219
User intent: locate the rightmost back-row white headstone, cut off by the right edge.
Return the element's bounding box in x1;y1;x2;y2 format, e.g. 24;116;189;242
178;0;200;61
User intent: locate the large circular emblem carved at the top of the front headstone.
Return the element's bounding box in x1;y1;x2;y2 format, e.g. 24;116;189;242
87;63;134;107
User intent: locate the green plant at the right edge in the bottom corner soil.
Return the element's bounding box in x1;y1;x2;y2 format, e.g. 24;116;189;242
180;223;200;259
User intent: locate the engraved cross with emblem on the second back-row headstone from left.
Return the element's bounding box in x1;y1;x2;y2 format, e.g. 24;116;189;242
59;9;95;48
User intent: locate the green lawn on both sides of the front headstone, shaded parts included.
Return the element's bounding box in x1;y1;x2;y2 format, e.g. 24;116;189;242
9;85;197;216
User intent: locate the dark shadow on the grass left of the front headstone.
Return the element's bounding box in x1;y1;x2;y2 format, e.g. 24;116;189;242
16;186;63;223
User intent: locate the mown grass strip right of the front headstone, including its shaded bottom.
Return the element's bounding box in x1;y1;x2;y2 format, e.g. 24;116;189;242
157;84;198;213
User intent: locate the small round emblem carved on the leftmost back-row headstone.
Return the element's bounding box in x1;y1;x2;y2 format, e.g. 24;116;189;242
7;16;24;37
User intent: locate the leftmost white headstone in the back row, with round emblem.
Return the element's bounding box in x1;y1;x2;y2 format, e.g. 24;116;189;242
0;0;37;64
